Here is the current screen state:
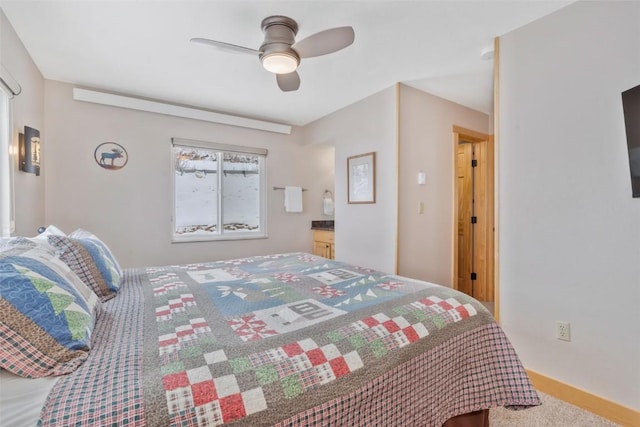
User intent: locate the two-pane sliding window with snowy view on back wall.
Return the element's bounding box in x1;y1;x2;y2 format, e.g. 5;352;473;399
173;138;267;242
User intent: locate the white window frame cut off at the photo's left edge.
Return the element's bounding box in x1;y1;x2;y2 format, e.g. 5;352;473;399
0;85;15;237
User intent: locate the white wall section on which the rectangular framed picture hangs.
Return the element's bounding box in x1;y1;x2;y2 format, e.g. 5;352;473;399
303;86;398;273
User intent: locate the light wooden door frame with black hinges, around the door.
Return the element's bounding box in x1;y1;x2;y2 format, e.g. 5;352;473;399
451;125;496;301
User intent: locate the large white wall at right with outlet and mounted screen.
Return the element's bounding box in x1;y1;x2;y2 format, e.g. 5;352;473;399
499;1;640;410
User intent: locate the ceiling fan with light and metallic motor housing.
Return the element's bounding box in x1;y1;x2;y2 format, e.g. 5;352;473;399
191;15;355;92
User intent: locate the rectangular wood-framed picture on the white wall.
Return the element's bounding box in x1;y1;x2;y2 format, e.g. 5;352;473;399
347;153;376;203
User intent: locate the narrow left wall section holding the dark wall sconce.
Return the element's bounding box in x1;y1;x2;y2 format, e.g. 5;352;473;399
0;10;44;236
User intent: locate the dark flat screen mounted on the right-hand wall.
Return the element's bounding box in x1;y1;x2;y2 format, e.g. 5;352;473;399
622;85;640;197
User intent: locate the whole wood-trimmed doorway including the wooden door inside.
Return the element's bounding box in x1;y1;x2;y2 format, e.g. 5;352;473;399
452;126;495;308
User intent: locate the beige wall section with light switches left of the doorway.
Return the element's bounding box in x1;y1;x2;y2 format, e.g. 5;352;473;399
398;85;489;286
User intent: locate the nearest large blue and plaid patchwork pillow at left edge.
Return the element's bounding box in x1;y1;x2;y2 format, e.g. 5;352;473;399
0;239;101;378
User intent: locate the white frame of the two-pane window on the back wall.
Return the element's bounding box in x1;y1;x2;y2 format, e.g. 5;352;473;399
171;138;268;243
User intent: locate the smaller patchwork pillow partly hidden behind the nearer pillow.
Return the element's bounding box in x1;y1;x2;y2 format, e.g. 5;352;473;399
47;235;122;302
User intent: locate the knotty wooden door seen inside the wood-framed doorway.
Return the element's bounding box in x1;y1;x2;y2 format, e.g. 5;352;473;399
456;142;474;296
